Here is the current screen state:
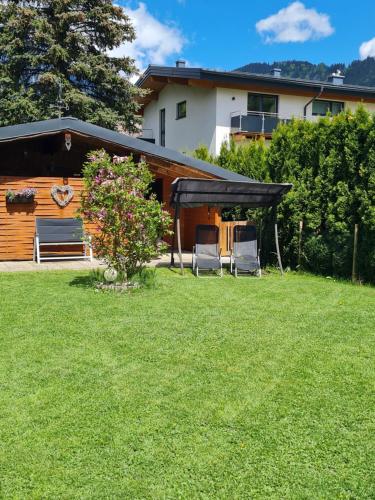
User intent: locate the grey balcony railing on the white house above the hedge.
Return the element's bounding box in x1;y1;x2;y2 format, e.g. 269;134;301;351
230;111;297;135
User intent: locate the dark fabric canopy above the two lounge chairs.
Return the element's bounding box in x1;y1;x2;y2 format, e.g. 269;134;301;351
171;178;292;208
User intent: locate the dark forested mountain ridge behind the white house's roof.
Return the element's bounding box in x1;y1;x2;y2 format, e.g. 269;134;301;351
235;57;375;87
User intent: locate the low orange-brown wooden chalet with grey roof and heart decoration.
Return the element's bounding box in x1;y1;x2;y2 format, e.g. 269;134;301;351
0;117;251;261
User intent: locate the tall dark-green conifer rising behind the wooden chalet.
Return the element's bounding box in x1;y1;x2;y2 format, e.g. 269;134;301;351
0;0;142;132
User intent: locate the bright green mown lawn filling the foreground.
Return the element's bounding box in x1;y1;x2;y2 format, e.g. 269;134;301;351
0;269;375;499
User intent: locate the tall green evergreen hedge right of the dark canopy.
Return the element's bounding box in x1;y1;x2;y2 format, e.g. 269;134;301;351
196;107;375;283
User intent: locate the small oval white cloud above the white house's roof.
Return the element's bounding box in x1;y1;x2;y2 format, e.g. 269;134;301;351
255;1;334;43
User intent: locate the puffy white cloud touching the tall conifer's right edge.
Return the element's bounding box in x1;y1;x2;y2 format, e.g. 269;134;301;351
111;2;186;76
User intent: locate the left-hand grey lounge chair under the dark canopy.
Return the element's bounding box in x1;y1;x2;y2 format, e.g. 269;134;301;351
192;224;223;276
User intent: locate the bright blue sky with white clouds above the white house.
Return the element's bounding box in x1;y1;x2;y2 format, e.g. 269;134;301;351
120;0;375;70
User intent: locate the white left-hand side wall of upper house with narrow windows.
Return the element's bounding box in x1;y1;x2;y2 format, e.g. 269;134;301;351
143;84;216;152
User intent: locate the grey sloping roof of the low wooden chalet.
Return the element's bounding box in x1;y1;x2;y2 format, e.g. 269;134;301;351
0;117;255;182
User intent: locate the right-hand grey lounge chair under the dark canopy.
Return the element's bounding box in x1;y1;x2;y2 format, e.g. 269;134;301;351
230;225;262;277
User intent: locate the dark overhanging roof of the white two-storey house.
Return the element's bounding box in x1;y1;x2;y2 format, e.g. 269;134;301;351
136;65;375;107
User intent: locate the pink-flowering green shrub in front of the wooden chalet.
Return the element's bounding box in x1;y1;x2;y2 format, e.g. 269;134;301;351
80;150;171;279
